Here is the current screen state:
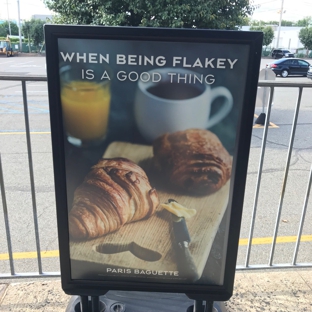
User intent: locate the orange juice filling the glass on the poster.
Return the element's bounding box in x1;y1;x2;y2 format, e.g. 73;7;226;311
61;80;111;141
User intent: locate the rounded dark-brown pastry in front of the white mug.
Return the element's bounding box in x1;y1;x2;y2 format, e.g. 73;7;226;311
153;129;232;195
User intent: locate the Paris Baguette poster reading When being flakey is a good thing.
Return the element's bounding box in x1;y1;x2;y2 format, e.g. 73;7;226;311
57;38;249;285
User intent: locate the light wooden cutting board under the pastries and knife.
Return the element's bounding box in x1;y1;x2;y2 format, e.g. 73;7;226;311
70;142;229;275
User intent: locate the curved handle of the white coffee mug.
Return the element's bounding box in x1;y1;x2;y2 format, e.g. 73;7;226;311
207;87;233;128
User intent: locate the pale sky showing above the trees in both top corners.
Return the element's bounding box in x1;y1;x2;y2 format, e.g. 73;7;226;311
0;0;312;21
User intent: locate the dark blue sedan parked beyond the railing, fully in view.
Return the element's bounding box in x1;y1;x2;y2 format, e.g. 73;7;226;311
266;58;311;78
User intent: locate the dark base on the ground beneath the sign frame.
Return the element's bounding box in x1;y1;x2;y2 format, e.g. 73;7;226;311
66;291;226;312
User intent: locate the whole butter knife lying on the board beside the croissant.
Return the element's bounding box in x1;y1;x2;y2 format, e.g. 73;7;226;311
168;199;199;282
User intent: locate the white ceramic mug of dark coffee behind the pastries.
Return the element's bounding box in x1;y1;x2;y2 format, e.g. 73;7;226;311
134;68;233;142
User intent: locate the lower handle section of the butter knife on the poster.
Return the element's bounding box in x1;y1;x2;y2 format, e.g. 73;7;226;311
177;242;199;282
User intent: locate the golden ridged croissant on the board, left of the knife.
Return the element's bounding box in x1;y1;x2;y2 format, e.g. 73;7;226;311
69;158;159;240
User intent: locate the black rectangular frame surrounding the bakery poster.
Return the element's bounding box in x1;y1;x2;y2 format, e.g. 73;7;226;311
45;25;263;301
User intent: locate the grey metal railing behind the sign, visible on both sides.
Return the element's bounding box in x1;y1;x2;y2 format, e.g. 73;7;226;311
0;76;312;279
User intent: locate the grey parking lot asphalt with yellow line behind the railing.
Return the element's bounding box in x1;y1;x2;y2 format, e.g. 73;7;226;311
0;56;312;272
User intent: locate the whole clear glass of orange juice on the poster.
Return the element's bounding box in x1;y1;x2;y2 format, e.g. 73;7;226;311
60;63;111;147
